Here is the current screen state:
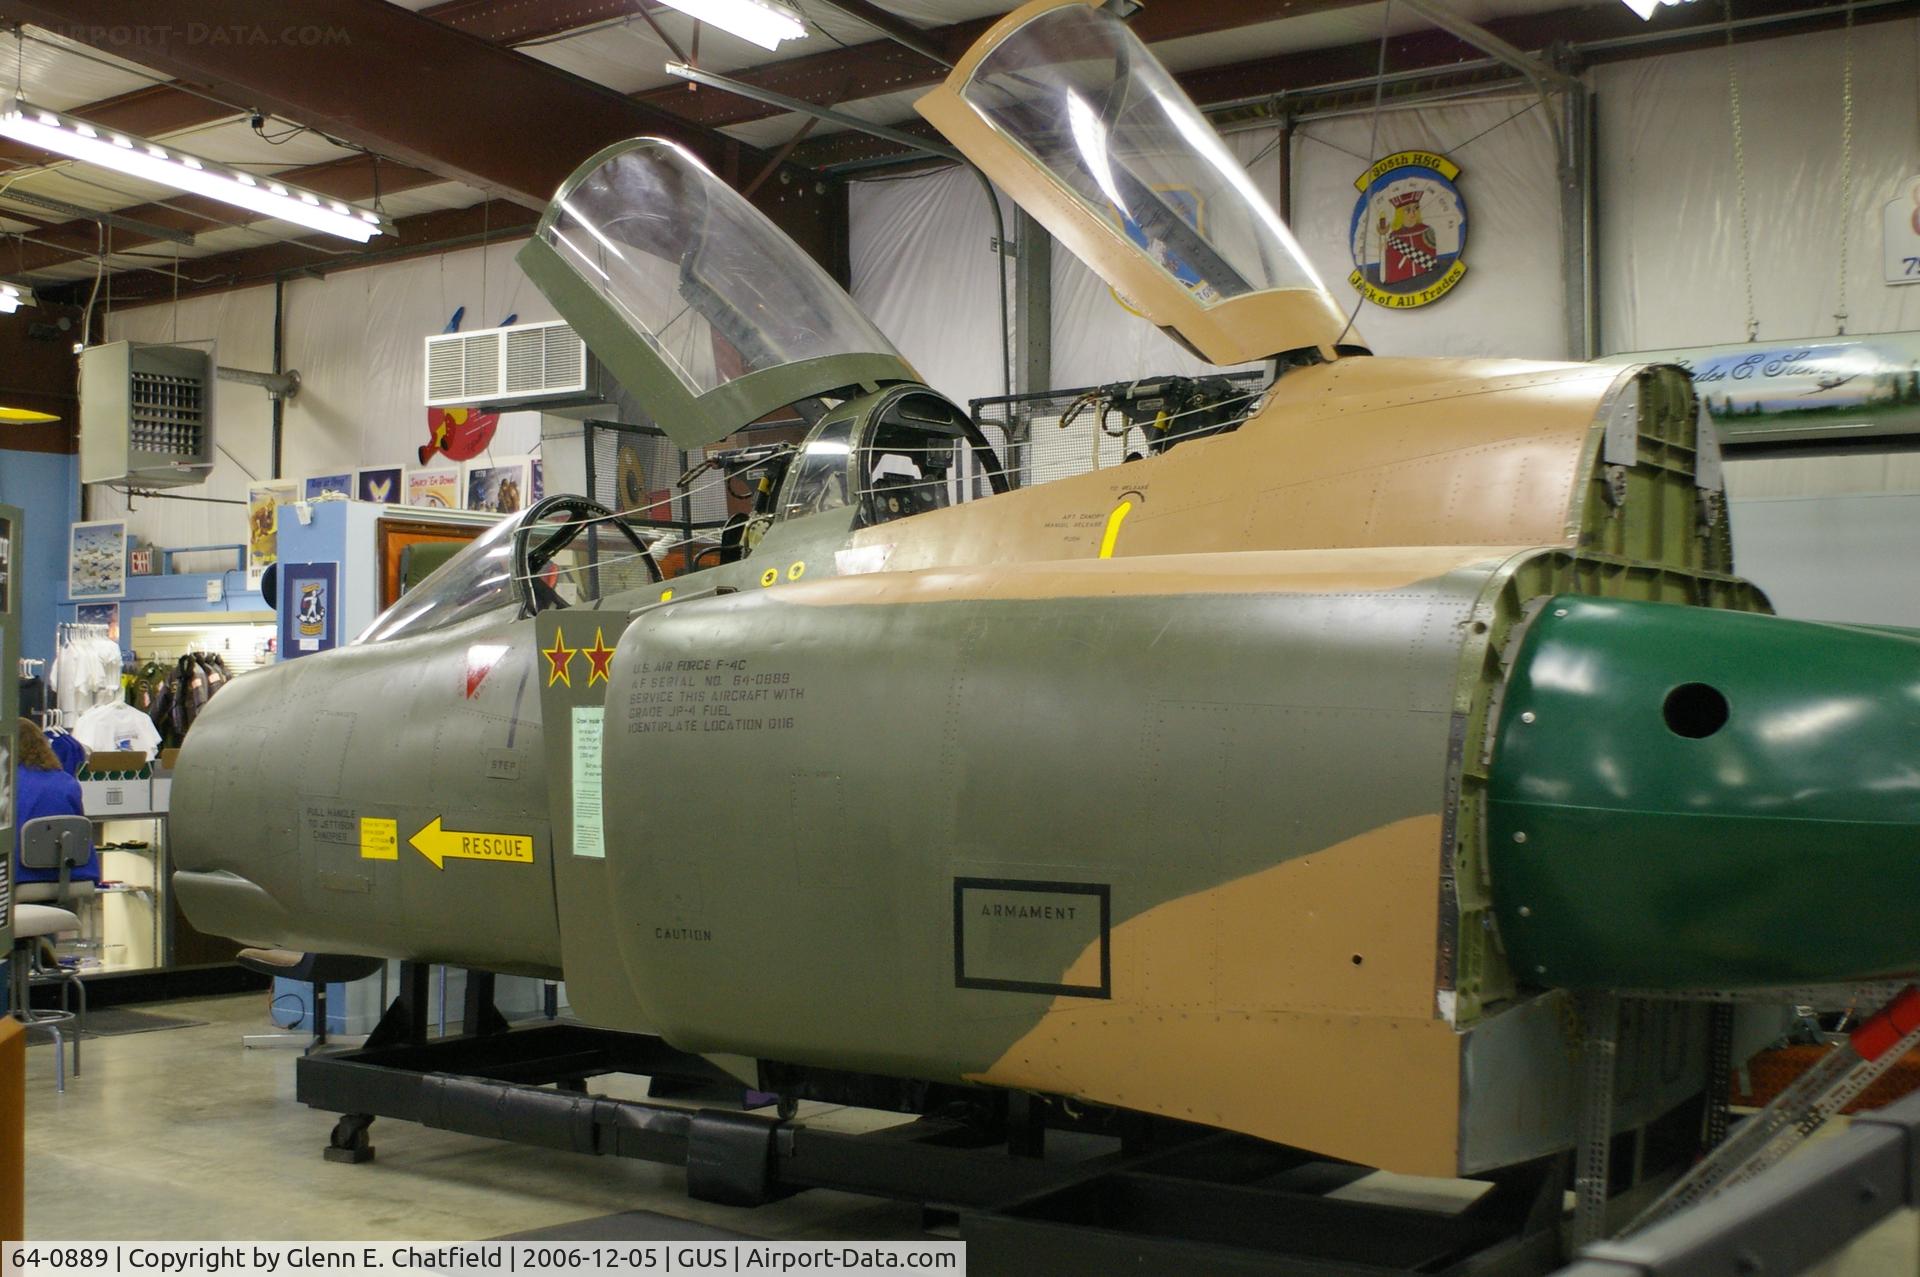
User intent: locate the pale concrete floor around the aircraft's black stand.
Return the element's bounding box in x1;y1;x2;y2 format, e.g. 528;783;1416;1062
15;995;1920;1277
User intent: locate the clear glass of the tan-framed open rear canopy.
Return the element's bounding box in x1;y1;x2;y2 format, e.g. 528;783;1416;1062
960;4;1323;305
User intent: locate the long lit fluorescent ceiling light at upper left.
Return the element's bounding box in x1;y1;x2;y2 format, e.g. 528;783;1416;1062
0;98;390;244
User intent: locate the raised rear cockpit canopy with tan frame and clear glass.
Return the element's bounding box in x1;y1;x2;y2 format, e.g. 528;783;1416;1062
918;0;1356;363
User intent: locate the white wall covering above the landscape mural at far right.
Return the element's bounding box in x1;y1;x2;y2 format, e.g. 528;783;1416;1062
1592;21;1920;353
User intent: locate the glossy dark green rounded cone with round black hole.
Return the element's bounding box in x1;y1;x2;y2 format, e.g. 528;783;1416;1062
1488;595;1920;989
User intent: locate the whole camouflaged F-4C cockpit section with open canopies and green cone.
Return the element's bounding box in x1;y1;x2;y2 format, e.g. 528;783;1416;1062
173;0;1920;1213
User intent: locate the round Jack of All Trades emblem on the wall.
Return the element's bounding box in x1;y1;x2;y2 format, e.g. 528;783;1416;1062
1346;150;1467;311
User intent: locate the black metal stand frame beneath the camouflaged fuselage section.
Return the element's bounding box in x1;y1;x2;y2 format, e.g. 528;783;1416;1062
296;962;1565;1277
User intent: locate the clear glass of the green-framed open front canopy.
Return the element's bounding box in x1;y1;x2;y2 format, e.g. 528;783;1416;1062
541;138;899;396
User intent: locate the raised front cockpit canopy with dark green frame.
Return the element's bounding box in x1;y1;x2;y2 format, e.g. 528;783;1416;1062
520;138;918;447
